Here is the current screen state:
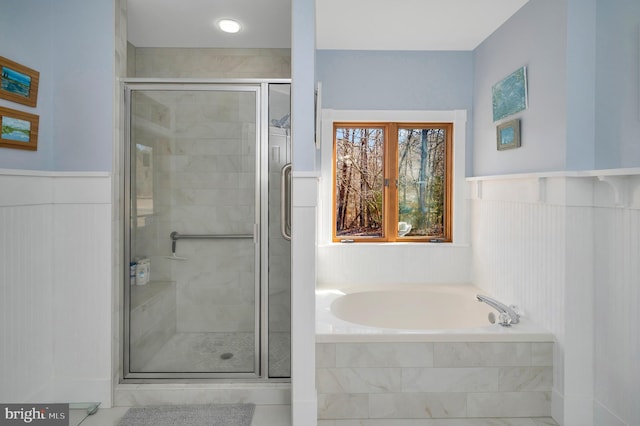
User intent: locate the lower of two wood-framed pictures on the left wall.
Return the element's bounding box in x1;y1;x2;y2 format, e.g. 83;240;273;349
0;107;39;151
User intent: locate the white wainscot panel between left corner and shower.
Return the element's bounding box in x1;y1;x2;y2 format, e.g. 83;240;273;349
52;173;112;405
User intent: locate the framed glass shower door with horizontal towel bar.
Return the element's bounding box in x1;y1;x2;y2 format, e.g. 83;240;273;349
125;84;260;378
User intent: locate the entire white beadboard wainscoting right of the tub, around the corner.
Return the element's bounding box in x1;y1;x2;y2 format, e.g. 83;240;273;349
468;169;640;426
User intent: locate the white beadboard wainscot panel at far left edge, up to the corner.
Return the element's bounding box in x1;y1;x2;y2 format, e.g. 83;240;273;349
0;170;54;403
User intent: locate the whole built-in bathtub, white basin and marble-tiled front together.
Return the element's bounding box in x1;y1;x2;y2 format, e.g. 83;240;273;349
316;285;554;424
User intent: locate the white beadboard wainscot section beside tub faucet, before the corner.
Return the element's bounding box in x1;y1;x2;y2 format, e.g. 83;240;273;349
471;174;566;406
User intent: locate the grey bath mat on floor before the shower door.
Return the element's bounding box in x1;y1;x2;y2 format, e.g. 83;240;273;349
118;404;255;426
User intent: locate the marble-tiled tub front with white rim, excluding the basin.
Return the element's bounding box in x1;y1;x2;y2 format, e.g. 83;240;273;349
316;287;554;426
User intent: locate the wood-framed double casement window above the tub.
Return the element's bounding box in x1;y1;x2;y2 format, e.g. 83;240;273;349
333;122;453;242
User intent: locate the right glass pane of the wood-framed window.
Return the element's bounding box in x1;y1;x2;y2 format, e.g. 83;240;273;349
398;128;446;238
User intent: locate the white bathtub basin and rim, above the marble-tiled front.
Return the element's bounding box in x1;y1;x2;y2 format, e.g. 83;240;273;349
316;284;553;342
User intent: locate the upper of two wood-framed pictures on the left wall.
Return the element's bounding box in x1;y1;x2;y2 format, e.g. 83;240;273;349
0;56;40;107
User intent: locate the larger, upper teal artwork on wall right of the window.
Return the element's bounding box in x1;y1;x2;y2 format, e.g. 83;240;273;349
491;67;528;123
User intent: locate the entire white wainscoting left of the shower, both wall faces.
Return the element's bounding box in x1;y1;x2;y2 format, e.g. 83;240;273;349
0;170;112;406
